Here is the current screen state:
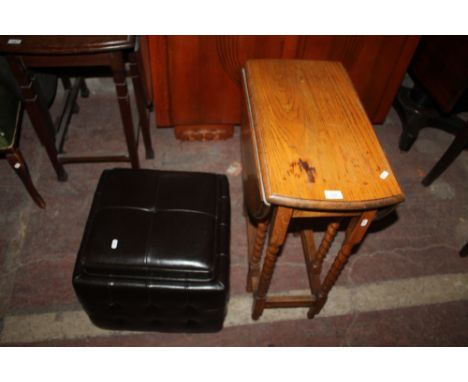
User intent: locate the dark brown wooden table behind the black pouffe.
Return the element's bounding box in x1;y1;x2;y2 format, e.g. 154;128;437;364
0;36;154;180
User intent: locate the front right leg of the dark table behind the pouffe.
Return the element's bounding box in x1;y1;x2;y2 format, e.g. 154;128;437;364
110;52;140;169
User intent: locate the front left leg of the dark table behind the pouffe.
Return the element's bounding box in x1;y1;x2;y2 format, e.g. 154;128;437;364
7;56;67;181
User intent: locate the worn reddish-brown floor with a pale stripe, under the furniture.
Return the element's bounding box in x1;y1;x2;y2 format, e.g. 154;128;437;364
0;80;468;346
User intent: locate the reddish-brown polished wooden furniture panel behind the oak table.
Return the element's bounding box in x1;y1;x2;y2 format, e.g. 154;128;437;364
149;36;419;138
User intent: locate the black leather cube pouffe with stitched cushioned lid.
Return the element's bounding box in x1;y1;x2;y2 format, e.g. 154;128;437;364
73;169;230;332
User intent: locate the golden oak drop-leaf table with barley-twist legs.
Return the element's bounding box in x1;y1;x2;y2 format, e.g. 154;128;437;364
242;60;404;319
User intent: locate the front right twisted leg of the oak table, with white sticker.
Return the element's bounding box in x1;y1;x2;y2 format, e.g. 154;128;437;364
307;210;376;318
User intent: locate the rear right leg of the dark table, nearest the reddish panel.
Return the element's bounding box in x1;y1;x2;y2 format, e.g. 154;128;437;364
129;54;154;159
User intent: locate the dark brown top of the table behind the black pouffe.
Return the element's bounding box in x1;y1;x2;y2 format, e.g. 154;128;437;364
0;36;135;55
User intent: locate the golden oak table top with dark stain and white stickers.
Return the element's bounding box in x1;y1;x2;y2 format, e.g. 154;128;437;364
243;60;404;211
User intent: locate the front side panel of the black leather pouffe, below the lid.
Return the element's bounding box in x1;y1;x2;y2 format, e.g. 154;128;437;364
74;277;227;331
